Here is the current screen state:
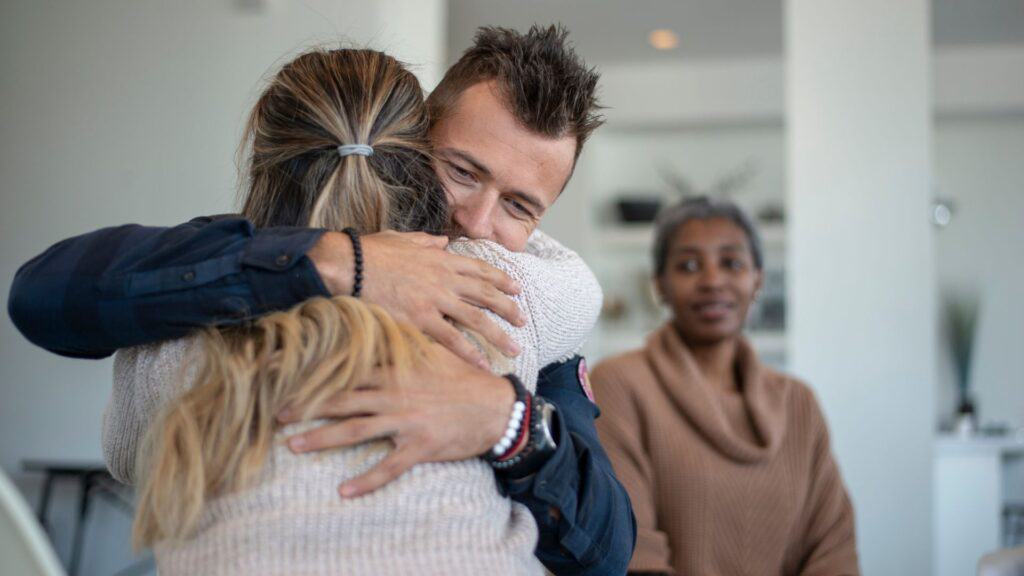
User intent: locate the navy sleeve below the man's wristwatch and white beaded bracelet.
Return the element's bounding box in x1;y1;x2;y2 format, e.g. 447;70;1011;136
502;357;636;575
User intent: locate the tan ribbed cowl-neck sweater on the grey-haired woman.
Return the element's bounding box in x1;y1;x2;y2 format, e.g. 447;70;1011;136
591;324;859;576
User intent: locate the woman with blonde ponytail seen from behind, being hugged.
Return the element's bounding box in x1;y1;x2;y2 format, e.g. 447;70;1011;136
103;49;601;575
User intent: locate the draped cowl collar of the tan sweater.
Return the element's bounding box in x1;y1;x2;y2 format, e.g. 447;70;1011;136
644;322;790;462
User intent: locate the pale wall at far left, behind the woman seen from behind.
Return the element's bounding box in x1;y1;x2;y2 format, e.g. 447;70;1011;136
0;0;445;574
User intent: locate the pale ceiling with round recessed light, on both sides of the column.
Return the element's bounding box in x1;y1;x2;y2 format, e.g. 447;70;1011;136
449;0;1024;64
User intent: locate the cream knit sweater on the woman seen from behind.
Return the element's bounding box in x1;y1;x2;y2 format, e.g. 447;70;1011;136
103;232;601;576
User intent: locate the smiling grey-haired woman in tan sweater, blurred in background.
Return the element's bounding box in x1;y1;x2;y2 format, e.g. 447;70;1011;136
593;198;859;576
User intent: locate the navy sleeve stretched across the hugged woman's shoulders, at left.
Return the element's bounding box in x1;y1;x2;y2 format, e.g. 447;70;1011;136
7;216;328;358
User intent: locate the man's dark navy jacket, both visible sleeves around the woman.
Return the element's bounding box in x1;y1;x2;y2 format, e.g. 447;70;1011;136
8;215;636;575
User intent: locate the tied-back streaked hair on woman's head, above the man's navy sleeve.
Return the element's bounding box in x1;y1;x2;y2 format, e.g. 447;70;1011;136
241;50;449;234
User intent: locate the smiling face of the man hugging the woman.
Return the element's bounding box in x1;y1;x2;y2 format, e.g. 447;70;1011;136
430;82;575;252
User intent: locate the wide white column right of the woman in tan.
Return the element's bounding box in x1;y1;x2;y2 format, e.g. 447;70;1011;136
785;0;936;574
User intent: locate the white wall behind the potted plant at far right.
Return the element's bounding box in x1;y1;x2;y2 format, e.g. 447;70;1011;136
935;115;1024;426
